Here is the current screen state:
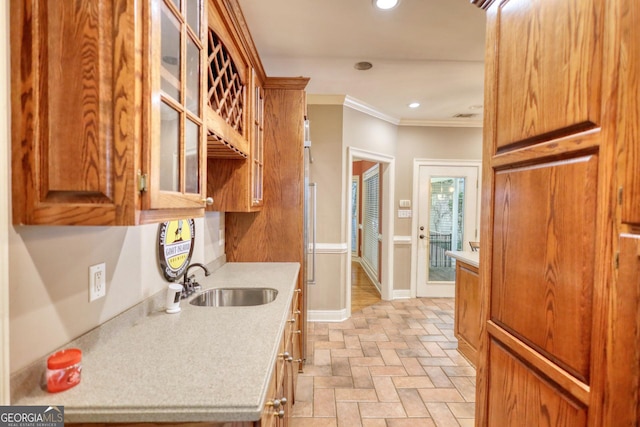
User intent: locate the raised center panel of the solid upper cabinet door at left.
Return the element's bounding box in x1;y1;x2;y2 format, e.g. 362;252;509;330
45;2;113;197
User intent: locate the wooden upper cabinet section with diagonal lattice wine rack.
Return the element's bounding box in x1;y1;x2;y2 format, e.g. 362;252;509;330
207;0;265;212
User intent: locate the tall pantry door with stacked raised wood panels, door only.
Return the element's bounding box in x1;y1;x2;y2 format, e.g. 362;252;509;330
476;0;615;427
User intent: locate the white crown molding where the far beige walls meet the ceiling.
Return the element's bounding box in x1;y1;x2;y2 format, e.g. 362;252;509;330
307;94;482;128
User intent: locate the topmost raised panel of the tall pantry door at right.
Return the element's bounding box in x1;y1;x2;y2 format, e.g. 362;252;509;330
495;0;603;150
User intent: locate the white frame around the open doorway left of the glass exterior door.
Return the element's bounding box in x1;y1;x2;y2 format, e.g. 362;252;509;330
342;146;396;318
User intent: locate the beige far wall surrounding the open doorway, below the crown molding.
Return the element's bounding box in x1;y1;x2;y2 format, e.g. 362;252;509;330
308;104;482;311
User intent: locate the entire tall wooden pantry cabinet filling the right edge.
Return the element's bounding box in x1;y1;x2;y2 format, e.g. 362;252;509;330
472;0;640;427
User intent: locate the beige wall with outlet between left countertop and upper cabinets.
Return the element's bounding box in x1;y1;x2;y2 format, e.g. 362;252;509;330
9;212;224;372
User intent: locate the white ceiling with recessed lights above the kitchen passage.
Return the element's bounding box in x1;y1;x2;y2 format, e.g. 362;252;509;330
239;0;486;126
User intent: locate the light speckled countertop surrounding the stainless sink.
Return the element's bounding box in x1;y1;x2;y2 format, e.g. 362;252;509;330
11;263;300;423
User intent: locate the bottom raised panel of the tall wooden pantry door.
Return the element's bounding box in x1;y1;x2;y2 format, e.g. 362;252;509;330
489;341;587;427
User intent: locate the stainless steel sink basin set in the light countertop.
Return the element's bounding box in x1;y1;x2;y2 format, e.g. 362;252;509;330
189;288;278;307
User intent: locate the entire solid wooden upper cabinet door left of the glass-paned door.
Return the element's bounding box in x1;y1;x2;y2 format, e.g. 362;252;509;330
11;1;139;225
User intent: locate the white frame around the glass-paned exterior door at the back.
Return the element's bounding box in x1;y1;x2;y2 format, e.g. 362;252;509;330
411;159;482;298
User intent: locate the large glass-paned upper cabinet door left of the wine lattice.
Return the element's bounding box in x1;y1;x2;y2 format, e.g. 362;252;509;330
142;0;206;209
